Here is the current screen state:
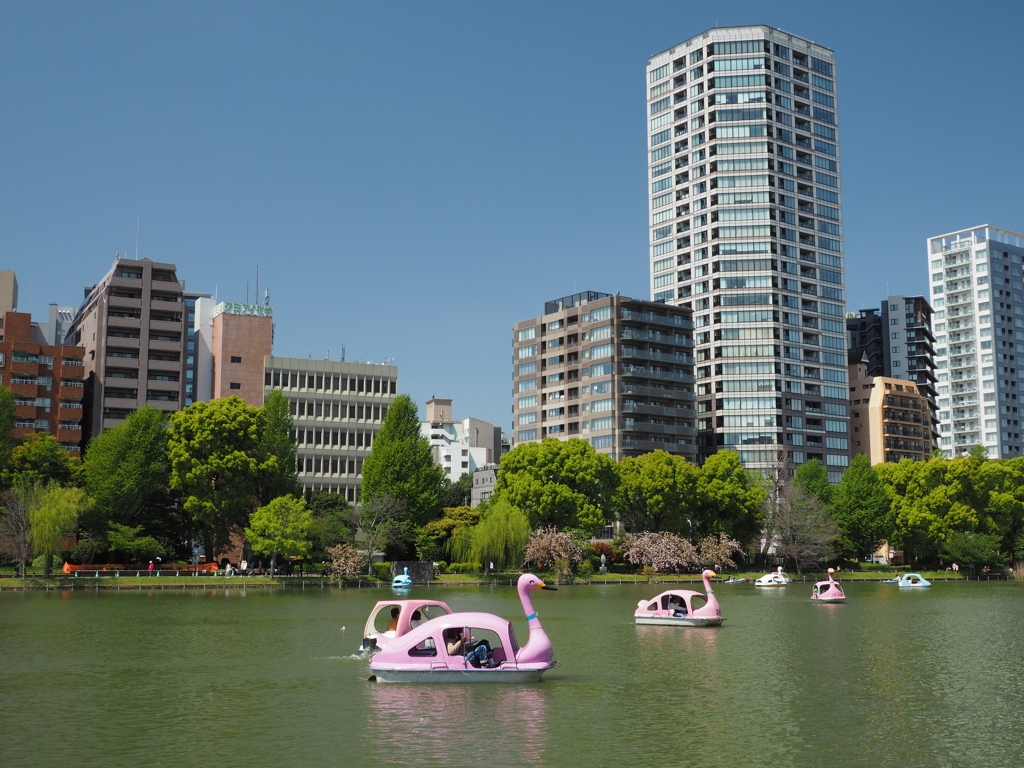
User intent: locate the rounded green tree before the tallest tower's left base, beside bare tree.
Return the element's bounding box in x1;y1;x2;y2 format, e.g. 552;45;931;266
687;451;768;544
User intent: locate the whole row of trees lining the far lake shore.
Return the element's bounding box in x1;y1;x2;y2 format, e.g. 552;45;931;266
0;387;1024;570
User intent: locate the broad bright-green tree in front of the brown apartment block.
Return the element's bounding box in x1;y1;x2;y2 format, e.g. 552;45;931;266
495;437;618;536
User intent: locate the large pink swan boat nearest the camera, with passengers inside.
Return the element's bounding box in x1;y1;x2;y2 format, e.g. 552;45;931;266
370;573;555;683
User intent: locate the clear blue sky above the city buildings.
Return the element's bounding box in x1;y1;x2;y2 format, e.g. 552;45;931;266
0;0;1024;429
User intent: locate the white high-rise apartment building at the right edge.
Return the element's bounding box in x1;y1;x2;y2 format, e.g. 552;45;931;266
928;224;1024;458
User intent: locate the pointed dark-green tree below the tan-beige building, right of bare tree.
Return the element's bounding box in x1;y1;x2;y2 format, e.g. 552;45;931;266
831;454;893;558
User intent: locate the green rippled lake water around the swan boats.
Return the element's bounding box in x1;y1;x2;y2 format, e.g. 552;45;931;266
0;582;1024;768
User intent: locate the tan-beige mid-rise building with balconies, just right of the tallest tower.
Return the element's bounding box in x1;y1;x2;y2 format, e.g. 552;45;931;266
850;359;934;465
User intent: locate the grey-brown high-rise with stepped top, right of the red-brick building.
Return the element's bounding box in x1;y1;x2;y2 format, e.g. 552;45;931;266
66;258;193;439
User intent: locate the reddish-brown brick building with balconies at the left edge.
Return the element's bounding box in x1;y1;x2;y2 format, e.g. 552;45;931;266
0;312;85;456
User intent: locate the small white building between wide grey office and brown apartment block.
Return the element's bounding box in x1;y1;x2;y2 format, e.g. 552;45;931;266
420;397;501;482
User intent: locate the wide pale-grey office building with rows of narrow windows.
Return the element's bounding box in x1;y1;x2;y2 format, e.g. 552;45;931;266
263;355;398;504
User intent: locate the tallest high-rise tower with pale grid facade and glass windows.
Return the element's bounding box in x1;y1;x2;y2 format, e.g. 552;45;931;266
646;27;850;480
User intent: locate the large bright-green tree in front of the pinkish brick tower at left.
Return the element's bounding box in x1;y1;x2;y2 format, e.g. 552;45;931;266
168;397;264;557
